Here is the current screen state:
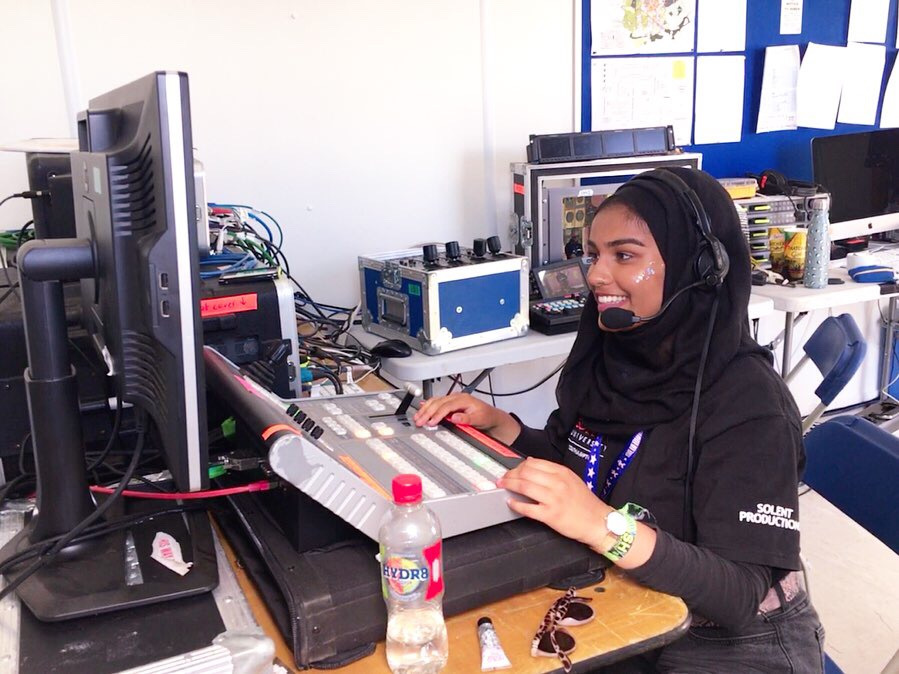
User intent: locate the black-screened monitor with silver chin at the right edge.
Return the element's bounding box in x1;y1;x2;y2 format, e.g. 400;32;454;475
812;129;899;239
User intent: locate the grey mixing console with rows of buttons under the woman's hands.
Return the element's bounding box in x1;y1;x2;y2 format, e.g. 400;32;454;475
204;348;523;540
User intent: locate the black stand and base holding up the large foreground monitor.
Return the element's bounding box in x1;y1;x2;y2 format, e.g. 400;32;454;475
0;239;218;621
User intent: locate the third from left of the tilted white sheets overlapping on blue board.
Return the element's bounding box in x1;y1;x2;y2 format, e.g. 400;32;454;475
837;42;886;126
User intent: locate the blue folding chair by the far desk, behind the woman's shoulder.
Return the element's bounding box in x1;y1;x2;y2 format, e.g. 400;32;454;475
784;314;867;434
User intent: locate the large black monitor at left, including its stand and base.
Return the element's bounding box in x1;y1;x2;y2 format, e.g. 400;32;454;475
0;72;218;620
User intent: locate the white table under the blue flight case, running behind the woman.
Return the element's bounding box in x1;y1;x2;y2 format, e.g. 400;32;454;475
350;296;774;398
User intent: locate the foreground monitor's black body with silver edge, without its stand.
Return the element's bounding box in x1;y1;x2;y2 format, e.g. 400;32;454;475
72;72;209;491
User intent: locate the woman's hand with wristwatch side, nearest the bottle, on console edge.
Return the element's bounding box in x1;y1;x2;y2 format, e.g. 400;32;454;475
497;458;612;546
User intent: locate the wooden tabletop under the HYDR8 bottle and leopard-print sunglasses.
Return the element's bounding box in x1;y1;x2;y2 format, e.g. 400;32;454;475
222;528;690;674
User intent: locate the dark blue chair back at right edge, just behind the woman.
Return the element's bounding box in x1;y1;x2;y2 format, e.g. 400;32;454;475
802;416;899;554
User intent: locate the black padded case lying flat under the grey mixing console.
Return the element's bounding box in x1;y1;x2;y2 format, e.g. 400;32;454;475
216;494;608;669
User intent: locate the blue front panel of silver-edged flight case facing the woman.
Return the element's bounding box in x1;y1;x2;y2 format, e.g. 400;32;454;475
439;271;521;338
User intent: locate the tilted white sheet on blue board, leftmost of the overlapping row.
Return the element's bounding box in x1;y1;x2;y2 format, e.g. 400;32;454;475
755;44;799;133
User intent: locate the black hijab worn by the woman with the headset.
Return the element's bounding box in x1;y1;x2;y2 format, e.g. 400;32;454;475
549;168;771;444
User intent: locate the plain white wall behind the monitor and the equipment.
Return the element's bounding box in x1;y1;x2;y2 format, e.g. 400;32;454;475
0;0;574;304
